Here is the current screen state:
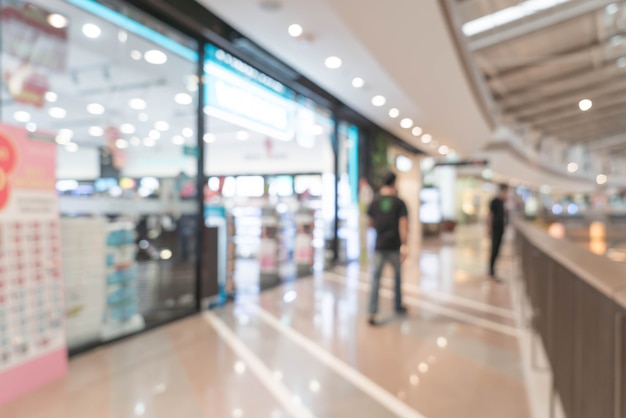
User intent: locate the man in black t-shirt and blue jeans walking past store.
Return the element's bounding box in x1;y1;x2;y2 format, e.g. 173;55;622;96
367;173;408;325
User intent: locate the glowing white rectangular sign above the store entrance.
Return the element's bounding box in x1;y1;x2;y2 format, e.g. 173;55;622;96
205;49;296;141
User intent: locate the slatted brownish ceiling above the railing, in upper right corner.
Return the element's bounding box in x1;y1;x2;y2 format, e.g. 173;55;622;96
456;0;626;153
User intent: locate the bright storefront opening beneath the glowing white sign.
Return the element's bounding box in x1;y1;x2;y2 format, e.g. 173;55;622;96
204;46;334;292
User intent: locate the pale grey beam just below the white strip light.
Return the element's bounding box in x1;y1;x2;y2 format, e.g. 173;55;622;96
468;0;615;51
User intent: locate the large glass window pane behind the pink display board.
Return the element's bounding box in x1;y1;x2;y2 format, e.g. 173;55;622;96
0;0;198;349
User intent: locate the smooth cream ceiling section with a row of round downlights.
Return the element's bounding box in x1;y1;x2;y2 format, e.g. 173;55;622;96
199;0;491;155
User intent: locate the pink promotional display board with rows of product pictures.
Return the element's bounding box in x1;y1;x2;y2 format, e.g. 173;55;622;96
0;125;67;404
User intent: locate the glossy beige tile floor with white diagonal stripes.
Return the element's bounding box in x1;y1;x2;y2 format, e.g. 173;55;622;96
0;228;530;418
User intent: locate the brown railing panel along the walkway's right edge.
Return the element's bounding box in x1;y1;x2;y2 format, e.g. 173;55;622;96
514;220;626;418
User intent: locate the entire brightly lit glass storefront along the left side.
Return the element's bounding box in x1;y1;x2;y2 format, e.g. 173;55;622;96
0;0;414;360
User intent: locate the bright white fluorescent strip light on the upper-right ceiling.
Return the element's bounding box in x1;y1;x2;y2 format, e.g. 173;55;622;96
463;0;569;36
